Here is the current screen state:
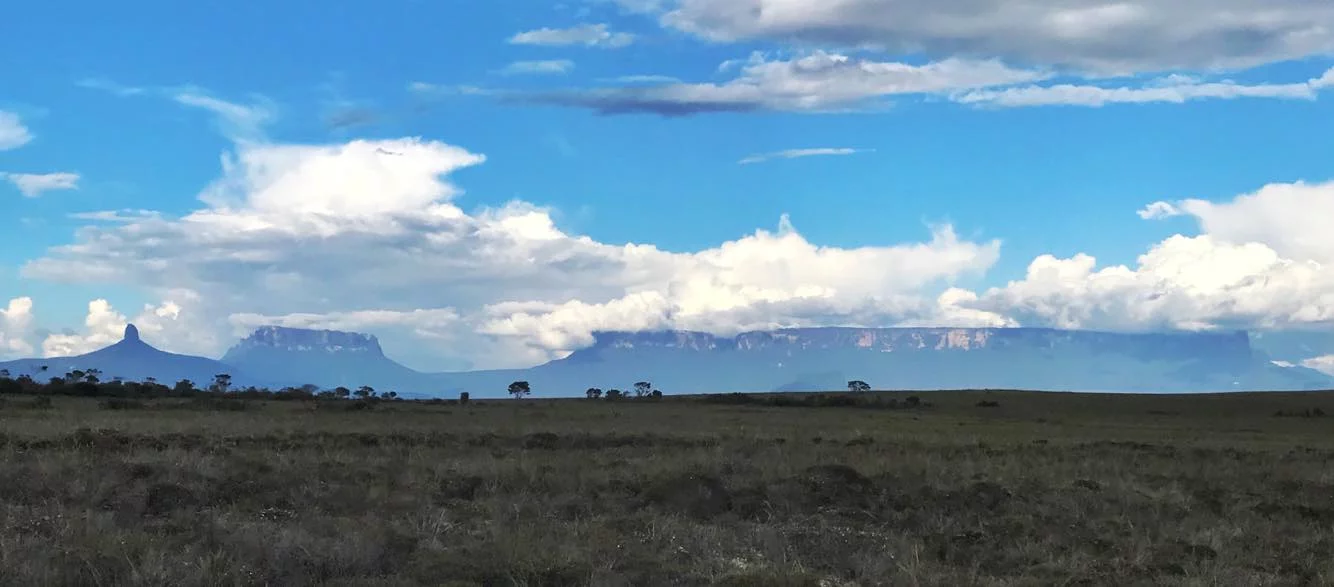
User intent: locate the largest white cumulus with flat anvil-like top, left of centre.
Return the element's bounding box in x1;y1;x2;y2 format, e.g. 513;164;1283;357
23;139;999;367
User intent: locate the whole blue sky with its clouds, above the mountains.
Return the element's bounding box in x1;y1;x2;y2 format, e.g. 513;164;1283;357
0;0;1334;368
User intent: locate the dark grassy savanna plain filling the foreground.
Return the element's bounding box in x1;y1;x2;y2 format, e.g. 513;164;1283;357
0;392;1334;586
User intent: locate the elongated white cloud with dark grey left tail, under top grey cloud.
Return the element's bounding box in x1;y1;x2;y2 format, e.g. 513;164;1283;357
524;51;1050;116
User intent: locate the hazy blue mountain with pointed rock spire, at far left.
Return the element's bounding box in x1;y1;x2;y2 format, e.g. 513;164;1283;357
0;324;256;387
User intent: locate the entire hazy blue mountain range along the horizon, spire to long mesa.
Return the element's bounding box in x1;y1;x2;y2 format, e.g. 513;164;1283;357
0;326;1334;398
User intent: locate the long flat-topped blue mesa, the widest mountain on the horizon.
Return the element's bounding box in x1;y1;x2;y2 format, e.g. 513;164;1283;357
496;322;1317;394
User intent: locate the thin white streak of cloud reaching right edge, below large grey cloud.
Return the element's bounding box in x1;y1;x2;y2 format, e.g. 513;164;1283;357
951;69;1334;108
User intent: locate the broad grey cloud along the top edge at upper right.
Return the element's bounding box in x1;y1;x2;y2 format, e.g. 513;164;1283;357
650;0;1334;73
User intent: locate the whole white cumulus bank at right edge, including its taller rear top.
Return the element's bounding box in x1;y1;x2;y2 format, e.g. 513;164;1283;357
964;178;1334;330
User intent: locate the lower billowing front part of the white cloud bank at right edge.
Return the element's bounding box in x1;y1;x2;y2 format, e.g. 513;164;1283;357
964;213;1334;337
